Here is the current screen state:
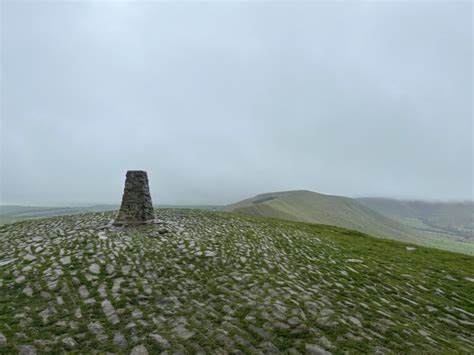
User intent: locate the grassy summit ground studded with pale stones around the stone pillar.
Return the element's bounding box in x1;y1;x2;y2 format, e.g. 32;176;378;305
0;209;474;354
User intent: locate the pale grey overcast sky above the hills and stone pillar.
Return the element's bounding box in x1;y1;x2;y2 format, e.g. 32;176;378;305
0;1;474;205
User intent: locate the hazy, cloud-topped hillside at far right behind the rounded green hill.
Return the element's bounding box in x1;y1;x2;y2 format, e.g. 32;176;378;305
357;198;474;242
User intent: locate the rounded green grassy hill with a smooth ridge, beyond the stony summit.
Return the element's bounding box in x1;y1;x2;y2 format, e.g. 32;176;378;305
224;190;474;254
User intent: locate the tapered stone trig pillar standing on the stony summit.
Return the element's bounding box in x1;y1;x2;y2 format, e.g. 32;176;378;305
114;170;154;225
